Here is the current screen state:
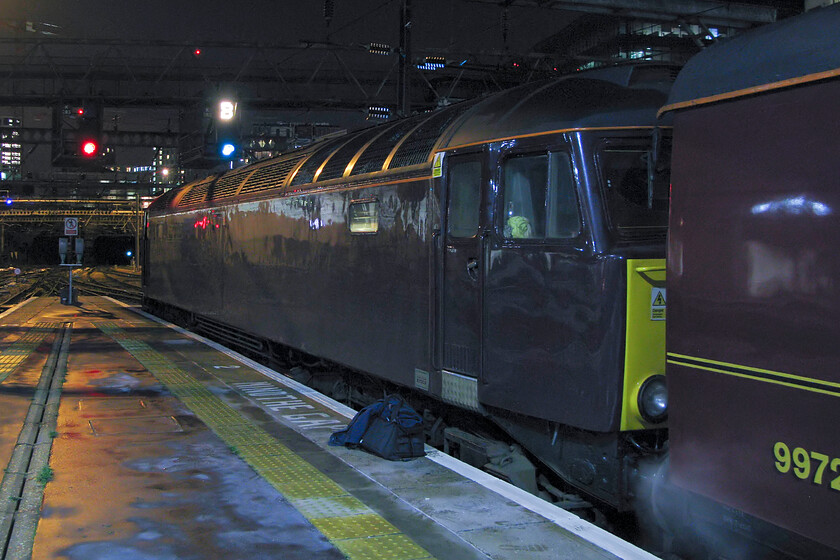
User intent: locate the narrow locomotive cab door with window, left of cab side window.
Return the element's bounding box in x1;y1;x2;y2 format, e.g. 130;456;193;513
436;153;487;409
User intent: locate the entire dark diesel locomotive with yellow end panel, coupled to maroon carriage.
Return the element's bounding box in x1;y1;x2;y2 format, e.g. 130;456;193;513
144;67;670;510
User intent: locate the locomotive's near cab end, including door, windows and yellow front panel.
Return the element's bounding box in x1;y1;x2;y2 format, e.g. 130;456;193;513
435;119;670;509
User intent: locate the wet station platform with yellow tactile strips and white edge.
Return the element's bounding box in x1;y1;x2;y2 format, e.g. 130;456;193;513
0;297;654;560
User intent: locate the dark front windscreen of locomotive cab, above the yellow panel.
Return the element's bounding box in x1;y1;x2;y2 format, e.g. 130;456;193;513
598;137;671;239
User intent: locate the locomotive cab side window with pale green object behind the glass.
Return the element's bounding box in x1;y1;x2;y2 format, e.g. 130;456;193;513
500;152;581;240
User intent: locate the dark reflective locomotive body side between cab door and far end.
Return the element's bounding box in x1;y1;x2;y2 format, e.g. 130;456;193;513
148;172;435;394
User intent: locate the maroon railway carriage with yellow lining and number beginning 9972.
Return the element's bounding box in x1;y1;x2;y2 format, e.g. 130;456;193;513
660;6;840;558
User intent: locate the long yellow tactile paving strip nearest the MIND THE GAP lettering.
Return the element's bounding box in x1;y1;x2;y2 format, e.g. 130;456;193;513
94;322;432;560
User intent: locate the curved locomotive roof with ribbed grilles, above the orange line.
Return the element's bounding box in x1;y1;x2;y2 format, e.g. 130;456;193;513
146;68;669;211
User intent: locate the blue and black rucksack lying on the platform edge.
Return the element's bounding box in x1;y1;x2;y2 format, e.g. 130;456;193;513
329;395;426;461
